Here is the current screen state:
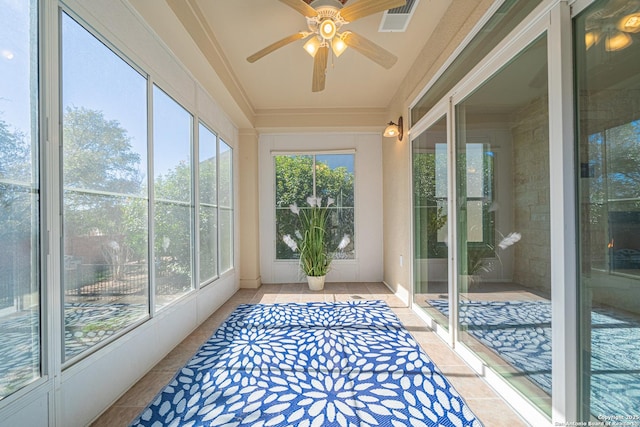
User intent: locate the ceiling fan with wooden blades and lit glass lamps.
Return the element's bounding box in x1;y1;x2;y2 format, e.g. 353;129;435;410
247;0;406;92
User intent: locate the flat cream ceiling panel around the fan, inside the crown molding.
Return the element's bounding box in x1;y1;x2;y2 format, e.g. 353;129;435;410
193;0;450;110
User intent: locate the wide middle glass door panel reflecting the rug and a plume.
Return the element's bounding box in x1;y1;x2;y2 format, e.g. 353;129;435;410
455;36;551;413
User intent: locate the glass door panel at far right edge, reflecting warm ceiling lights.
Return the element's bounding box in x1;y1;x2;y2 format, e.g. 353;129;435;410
574;1;640;425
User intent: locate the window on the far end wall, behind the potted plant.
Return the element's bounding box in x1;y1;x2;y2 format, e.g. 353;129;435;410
274;154;355;260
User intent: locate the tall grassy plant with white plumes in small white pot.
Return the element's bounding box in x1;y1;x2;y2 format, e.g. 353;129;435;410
282;196;350;291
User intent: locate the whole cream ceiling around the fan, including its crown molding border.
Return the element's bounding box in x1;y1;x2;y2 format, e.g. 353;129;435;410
128;0;492;127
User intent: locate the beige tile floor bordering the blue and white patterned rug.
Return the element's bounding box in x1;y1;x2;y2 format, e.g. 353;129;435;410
91;283;528;427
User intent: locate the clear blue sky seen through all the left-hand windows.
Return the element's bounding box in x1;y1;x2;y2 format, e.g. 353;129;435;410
0;6;215;181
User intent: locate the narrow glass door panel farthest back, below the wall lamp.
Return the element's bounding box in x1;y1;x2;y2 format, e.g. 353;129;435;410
412;117;449;328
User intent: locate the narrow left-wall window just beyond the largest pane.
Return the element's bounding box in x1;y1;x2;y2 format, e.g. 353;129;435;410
153;86;193;308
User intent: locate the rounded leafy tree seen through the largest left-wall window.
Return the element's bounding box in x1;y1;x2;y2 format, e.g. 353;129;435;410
62;107;146;242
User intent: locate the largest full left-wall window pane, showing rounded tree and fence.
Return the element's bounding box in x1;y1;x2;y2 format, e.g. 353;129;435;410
61;13;149;361
